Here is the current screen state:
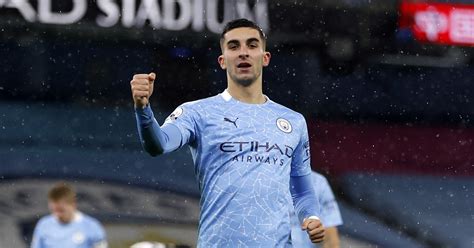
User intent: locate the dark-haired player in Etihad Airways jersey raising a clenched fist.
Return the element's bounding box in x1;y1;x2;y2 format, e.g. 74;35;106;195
130;19;324;247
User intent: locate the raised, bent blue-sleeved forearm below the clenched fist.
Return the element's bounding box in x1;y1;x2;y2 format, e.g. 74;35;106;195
135;106;182;156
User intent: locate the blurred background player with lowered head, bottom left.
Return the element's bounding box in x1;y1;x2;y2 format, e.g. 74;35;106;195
31;182;107;248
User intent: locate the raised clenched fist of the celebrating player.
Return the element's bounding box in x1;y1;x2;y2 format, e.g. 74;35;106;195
130;72;156;108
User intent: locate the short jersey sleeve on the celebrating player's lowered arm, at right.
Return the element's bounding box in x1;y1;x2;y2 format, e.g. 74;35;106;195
291;116;311;176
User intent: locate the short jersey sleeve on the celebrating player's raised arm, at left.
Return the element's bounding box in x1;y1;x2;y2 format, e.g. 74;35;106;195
163;103;197;146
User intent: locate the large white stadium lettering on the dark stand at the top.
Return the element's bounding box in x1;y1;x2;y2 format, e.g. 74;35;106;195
0;0;270;33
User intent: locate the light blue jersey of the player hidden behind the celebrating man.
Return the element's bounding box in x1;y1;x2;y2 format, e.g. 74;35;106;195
291;172;342;248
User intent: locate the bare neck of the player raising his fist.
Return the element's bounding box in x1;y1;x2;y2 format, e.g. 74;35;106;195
227;77;267;104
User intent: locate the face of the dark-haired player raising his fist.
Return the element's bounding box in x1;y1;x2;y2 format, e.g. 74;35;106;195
218;28;270;86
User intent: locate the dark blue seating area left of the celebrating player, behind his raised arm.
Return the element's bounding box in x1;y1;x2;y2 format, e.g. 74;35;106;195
0;103;199;196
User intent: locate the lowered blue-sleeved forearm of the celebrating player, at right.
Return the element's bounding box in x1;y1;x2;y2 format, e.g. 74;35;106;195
290;174;320;223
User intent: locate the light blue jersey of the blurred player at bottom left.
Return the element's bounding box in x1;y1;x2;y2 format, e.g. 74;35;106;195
31;212;107;248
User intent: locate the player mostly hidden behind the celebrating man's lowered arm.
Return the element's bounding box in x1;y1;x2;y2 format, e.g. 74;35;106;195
291;171;342;248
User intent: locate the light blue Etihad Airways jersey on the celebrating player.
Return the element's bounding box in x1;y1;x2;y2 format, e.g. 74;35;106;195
164;91;312;247
